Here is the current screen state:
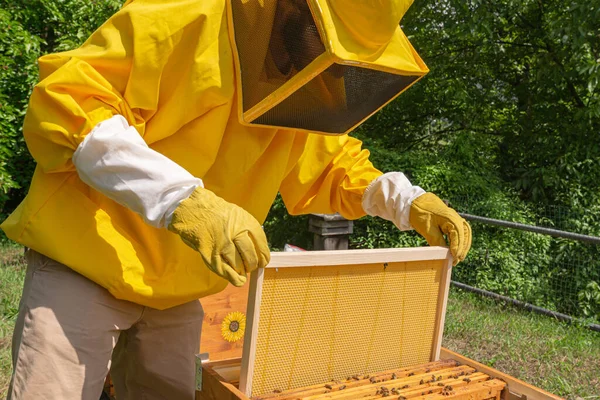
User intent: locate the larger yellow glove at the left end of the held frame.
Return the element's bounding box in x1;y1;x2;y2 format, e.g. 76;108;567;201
169;187;271;286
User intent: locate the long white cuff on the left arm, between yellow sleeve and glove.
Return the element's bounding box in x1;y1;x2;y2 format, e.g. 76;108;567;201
73;115;204;228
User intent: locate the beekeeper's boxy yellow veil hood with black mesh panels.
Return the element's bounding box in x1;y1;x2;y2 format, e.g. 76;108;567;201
227;0;428;135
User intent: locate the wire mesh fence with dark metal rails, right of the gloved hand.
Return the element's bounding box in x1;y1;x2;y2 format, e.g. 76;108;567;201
450;198;600;327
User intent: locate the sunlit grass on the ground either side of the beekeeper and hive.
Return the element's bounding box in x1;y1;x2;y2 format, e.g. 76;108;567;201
0;245;600;399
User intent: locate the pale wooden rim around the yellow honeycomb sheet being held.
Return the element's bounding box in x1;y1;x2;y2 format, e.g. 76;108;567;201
240;247;452;397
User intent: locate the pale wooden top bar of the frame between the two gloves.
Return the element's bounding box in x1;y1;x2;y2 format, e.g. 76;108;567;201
267;246;450;268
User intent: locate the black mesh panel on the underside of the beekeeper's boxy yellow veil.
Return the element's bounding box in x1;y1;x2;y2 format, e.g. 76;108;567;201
253;65;419;134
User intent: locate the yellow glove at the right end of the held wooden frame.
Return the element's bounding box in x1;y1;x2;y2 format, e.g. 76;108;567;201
409;193;471;265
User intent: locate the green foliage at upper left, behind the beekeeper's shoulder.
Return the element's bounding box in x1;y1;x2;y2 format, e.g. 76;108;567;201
0;0;122;223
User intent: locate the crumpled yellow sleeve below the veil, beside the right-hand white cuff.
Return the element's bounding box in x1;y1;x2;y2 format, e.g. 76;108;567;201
279;134;382;219
